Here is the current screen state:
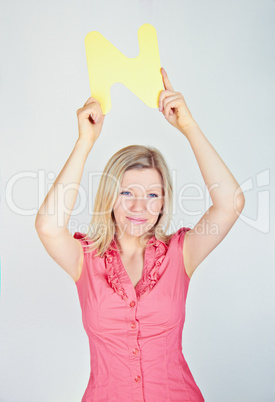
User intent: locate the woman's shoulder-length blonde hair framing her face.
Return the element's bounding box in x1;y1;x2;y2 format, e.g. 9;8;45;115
81;145;173;257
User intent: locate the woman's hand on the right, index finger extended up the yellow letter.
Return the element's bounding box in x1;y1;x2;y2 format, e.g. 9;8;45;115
159;67;197;134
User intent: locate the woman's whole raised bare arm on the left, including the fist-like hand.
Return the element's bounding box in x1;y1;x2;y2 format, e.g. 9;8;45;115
35;98;105;281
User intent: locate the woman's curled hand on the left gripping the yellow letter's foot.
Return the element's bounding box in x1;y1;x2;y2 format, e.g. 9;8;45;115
76;97;105;144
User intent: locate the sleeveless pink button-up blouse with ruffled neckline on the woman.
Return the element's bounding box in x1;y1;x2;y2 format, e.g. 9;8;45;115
74;228;204;402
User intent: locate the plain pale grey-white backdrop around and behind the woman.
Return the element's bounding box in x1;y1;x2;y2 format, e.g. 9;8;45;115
0;0;275;402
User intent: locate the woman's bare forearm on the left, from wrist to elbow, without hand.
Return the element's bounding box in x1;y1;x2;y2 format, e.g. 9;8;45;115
35;139;94;233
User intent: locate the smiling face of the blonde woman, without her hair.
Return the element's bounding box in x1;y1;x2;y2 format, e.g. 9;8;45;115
113;168;163;238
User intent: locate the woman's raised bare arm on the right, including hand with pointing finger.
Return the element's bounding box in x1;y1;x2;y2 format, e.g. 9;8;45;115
159;69;245;278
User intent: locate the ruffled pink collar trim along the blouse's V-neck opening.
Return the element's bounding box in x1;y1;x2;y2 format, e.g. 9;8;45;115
104;236;168;301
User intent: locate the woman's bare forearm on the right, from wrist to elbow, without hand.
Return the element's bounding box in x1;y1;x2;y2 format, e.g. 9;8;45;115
181;123;244;212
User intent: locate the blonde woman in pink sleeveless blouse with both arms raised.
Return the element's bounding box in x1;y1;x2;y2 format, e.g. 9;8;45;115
36;69;244;402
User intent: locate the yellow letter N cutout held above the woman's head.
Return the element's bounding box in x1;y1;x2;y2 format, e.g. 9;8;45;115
85;24;164;114
